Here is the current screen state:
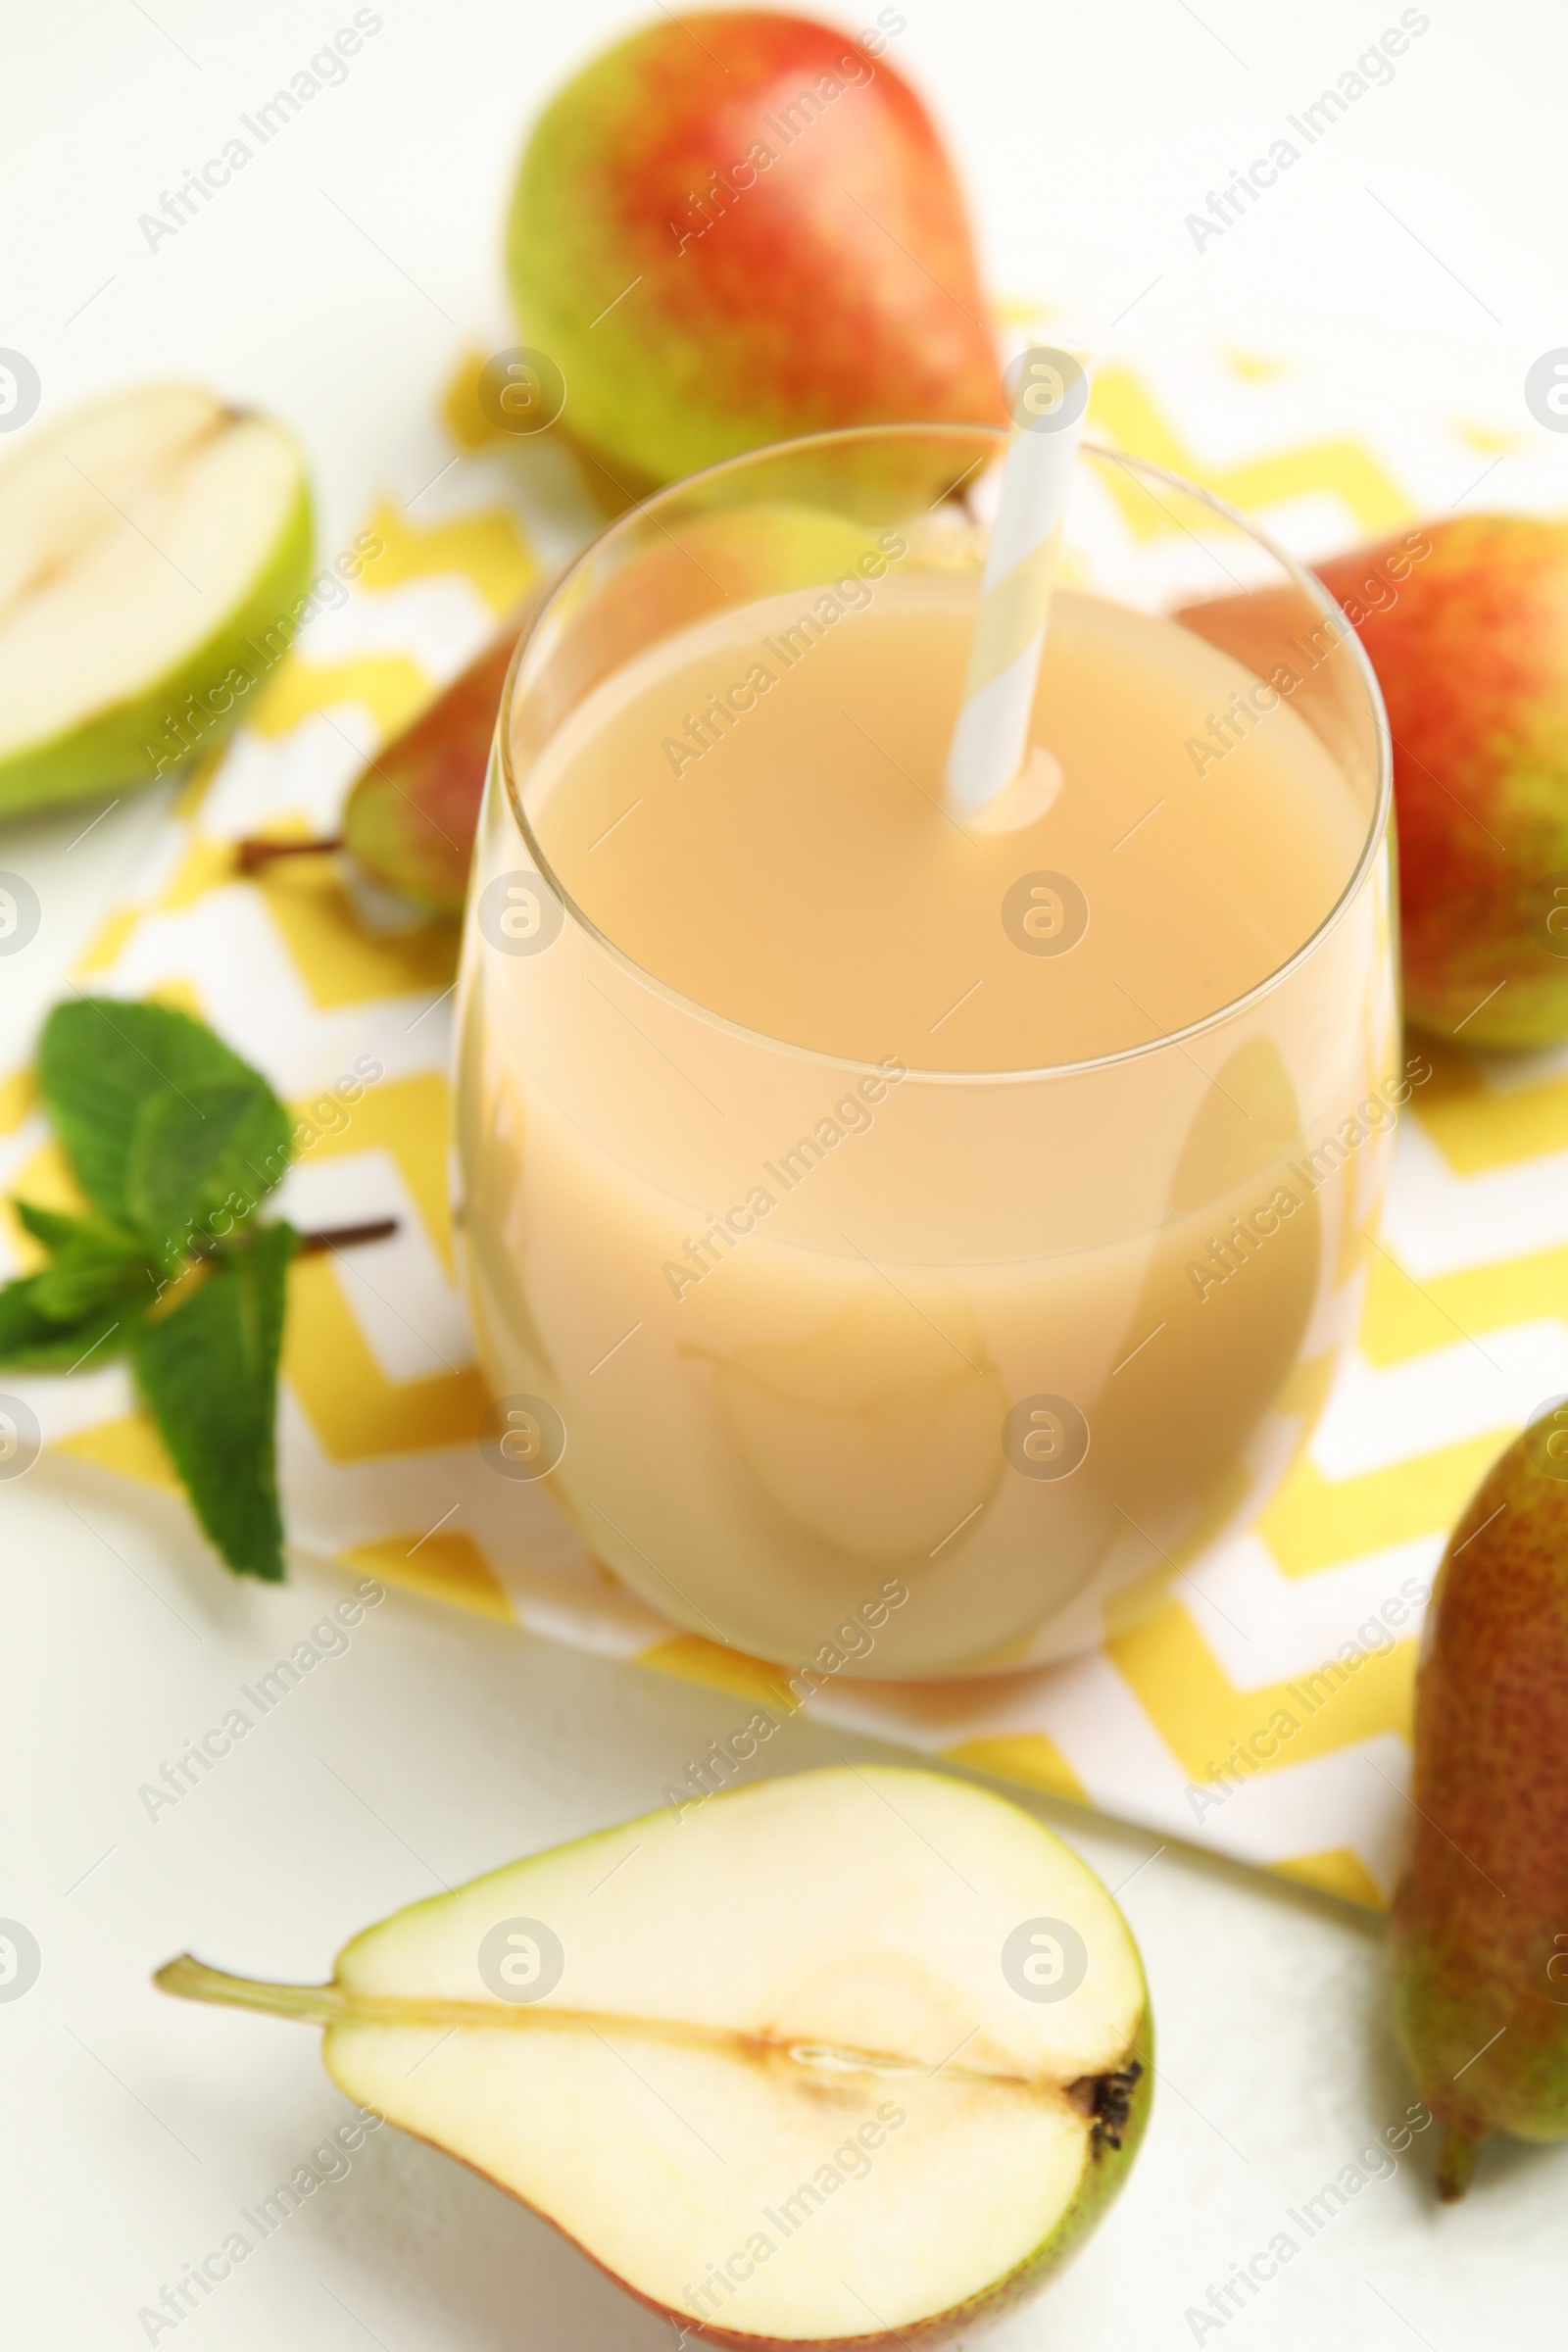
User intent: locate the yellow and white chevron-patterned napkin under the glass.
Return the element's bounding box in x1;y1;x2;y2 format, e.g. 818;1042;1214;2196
0;353;1568;1905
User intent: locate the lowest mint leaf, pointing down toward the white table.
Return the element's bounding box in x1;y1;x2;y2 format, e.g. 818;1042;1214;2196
129;1225;299;1583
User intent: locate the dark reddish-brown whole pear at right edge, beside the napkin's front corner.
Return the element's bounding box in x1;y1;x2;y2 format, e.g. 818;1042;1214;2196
1390;1401;1568;2199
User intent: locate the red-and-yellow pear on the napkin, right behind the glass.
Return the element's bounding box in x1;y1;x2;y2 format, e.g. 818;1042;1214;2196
1319;515;1568;1047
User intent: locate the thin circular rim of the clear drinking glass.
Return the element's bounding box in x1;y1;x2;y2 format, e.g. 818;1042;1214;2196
494;423;1394;1087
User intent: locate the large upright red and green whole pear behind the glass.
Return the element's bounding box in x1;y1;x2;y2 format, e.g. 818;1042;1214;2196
508;10;1004;482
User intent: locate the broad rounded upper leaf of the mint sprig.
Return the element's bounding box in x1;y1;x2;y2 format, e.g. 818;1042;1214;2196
37;998;289;1263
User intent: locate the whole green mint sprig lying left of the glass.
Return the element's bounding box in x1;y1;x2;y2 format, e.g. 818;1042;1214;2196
0;998;299;1581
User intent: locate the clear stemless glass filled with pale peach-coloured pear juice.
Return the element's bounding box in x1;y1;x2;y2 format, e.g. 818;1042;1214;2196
459;425;1408;1689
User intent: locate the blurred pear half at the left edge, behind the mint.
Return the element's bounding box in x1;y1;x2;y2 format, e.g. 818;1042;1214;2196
0;383;311;813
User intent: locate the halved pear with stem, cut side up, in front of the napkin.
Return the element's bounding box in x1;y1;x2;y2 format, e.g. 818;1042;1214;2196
158;1766;1150;2352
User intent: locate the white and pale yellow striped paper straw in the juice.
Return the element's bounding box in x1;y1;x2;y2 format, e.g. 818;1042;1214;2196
945;343;1089;816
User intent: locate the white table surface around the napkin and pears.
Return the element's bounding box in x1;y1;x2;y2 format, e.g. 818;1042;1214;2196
0;0;1568;2352
